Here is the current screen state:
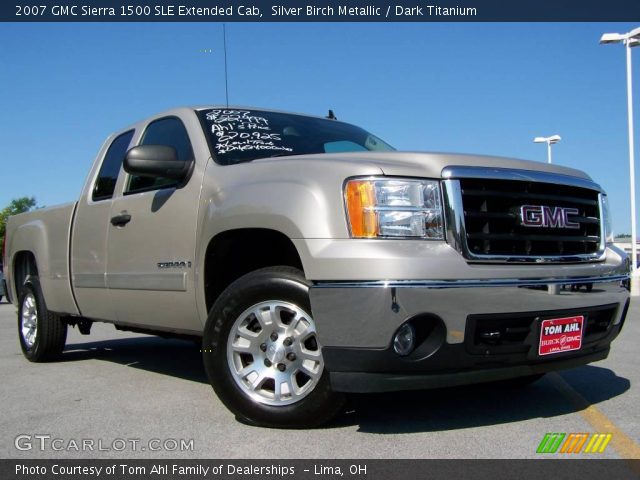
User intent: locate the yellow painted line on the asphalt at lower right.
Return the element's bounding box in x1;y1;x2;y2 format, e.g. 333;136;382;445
548;372;640;462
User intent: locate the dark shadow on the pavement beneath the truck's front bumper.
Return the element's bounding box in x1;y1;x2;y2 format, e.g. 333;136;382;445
336;365;631;434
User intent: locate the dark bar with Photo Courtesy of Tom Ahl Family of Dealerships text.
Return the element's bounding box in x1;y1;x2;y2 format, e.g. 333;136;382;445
0;458;640;480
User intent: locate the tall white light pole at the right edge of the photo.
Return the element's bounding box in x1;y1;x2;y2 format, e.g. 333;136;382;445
600;27;640;296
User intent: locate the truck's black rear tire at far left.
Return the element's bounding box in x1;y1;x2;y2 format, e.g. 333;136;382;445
18;277;67;362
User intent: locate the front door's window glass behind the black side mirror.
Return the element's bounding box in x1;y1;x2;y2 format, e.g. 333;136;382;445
126;117;194;193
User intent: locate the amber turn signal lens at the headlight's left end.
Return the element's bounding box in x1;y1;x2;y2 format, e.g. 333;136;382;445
345;180;378;238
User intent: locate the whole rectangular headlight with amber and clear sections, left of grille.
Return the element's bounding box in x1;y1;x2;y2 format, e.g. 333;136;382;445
344;178;444;240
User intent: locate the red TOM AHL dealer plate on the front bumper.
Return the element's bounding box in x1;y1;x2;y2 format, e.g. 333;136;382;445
538;315;584;356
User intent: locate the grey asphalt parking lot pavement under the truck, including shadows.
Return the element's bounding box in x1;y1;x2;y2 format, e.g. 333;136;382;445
0;300;640;459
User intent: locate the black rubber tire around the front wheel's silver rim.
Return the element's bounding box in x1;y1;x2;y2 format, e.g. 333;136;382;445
202;267;344;428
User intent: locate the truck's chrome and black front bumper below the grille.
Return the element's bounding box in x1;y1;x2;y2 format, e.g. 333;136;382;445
310;275;629;392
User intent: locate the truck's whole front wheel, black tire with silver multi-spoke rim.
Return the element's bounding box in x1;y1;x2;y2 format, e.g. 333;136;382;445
203;267;343;428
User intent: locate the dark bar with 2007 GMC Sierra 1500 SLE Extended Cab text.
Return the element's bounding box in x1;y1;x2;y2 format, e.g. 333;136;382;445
0;0;640;22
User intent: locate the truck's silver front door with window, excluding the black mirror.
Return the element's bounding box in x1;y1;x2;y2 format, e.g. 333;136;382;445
107;116;206;333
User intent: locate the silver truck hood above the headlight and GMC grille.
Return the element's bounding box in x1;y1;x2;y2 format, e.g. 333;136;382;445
252;152;591;180
